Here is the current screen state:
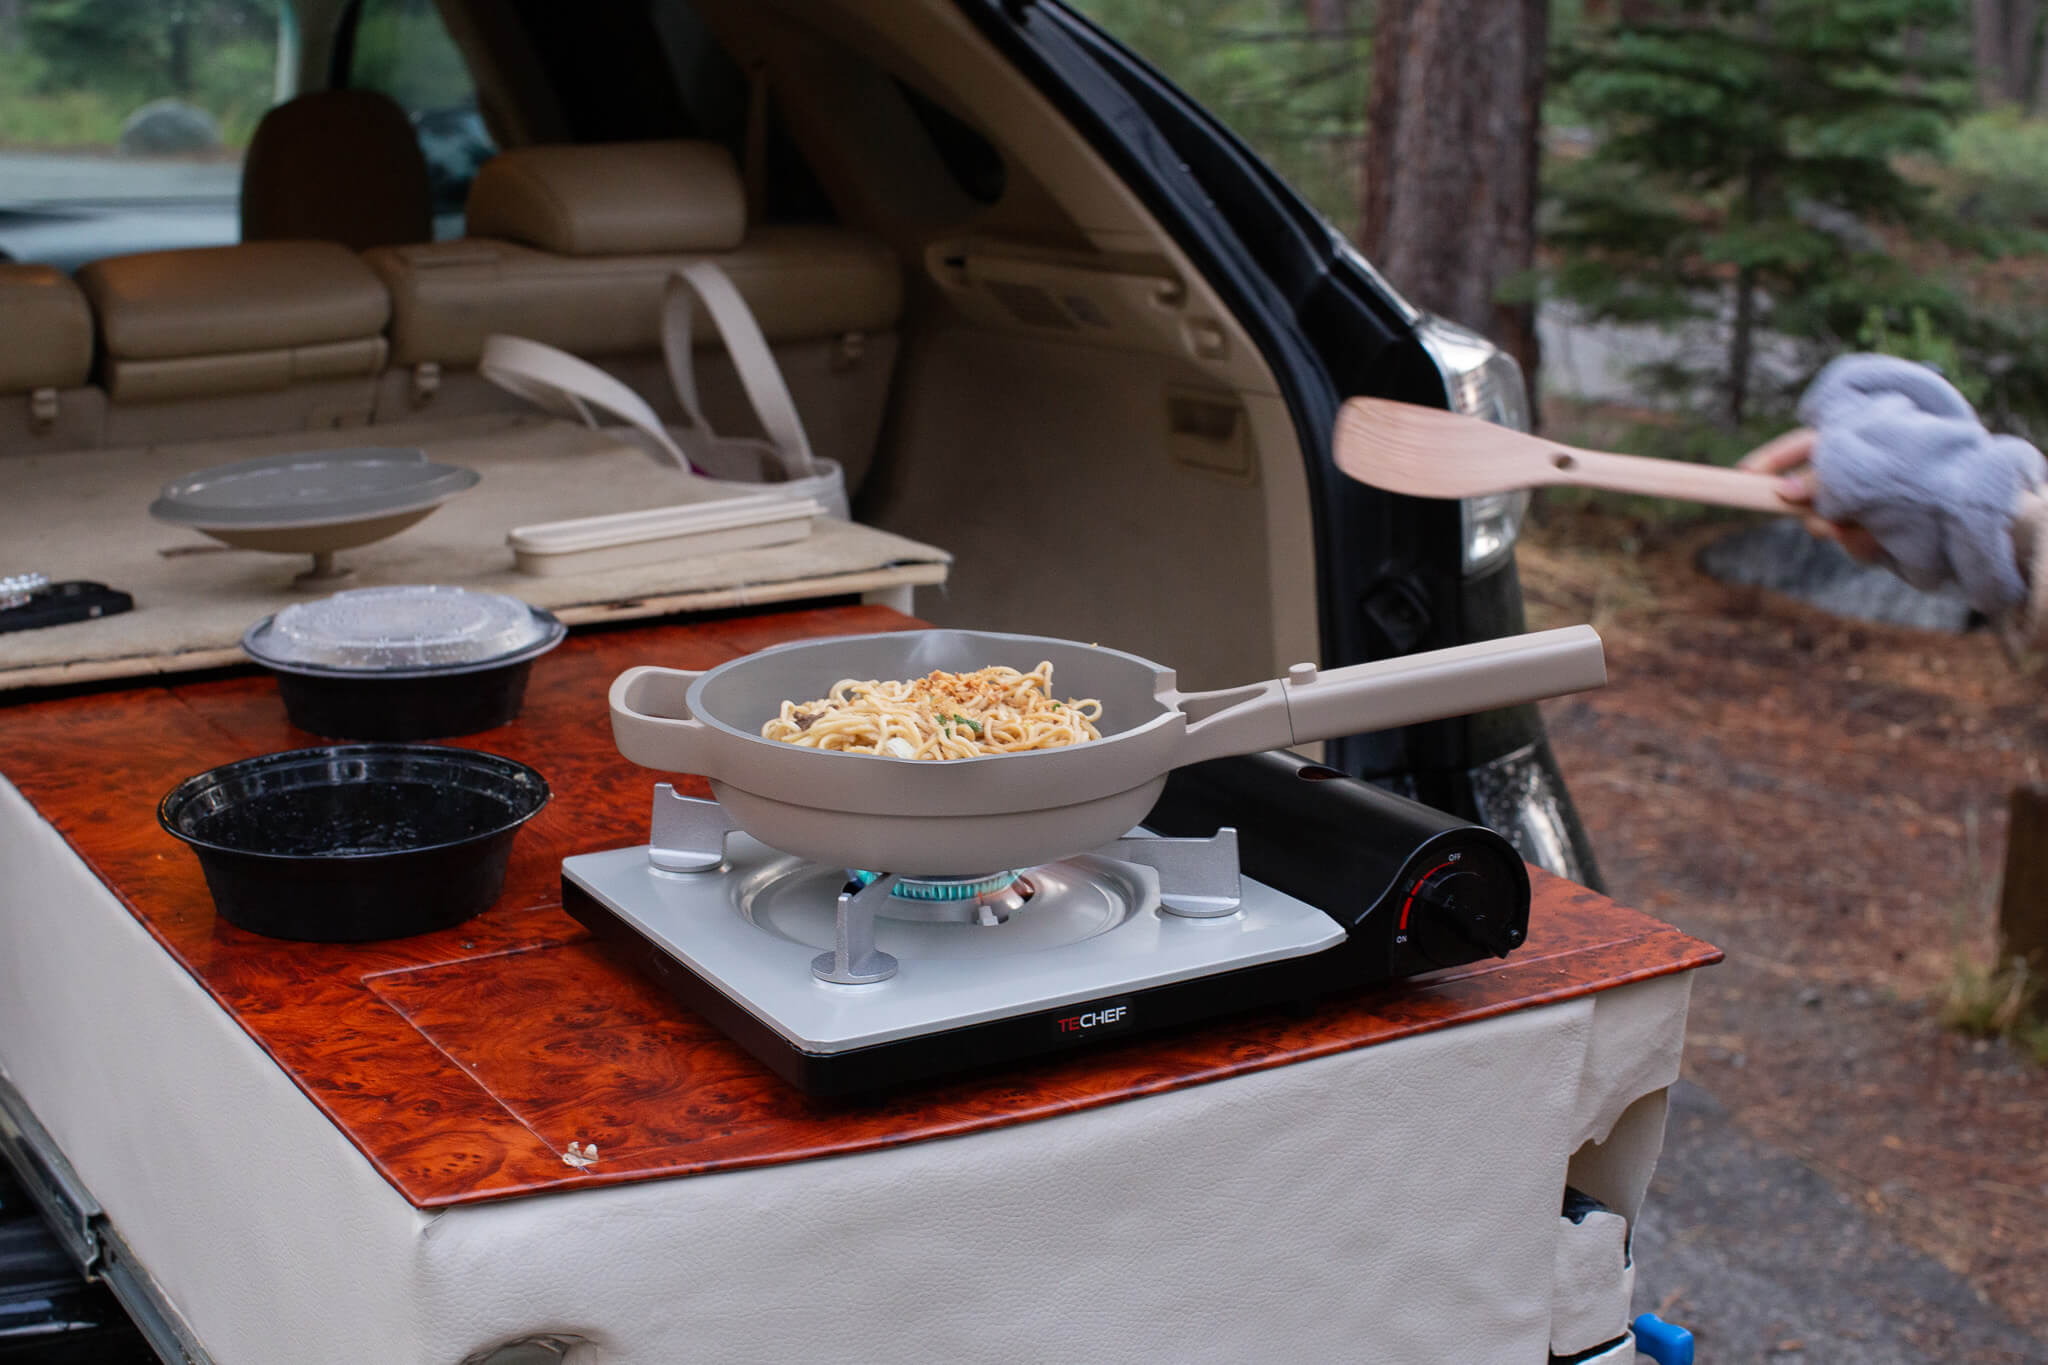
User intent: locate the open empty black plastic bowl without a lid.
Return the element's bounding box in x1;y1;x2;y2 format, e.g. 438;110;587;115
156;745;549;943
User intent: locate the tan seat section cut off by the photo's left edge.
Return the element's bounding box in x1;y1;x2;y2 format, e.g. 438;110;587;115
0;262;104;452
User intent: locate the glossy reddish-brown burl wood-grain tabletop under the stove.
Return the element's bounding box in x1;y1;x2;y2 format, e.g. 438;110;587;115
0;606;1720;1207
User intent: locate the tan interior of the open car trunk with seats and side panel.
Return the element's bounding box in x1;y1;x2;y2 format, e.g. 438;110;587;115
0;0;1319;703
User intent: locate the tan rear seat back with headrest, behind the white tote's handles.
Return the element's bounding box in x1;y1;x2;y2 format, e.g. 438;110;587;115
365;141;903;481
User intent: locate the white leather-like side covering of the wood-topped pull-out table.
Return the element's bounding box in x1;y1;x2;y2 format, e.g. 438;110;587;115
0;784;1690;1365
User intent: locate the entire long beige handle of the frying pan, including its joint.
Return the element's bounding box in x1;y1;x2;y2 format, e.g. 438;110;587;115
1169;626;1608;765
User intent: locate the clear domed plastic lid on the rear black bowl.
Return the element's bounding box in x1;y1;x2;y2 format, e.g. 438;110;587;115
242;585;563;673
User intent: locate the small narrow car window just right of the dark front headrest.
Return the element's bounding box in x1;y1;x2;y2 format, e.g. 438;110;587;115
336;0;498;237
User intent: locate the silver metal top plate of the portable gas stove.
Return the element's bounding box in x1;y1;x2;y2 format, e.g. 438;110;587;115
561;831;1343;1056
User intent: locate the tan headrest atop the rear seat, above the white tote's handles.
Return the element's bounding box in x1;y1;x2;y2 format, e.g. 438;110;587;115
467;141;748;256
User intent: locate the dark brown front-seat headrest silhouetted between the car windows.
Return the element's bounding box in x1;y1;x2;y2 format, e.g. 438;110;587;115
242;90;434;252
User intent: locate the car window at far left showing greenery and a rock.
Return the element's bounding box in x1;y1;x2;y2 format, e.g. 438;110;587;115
0;0;299;268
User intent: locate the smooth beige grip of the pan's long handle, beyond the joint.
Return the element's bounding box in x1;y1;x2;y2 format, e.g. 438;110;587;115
1282;626;1608;745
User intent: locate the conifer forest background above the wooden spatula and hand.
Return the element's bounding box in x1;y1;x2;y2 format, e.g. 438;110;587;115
1077;0;2048;460
